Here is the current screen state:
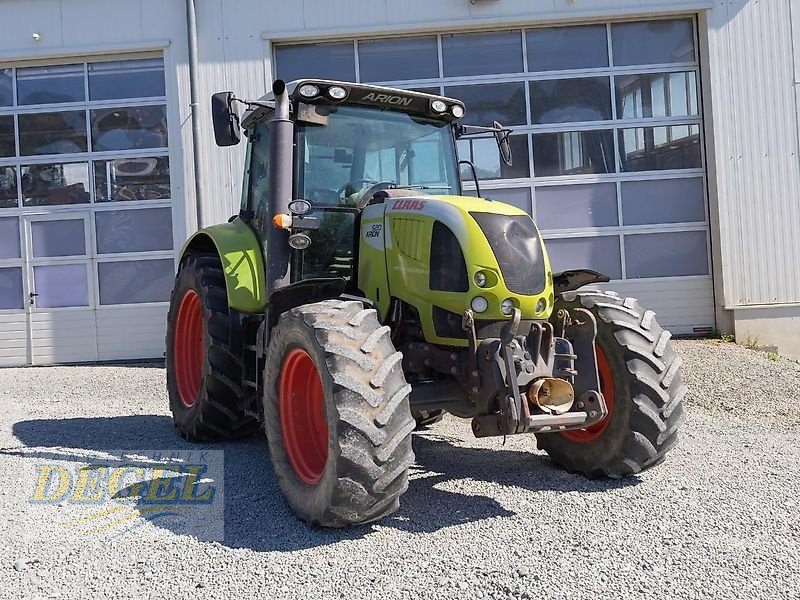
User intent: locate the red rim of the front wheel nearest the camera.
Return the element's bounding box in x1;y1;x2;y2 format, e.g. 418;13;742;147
279;348;328;485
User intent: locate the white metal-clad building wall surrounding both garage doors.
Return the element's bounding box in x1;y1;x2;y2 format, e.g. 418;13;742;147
0;0;800;353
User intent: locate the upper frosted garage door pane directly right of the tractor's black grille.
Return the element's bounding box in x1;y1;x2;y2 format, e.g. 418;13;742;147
545;236;622;279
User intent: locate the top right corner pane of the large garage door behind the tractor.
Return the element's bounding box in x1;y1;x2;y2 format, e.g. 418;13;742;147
611;19;696;66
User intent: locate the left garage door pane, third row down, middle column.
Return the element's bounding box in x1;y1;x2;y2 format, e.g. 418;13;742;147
22;163;89;206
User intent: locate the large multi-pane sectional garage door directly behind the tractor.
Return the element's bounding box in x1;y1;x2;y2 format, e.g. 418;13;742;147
273;17;714;334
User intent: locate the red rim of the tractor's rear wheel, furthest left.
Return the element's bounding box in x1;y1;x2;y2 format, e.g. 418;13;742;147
172;290;205;408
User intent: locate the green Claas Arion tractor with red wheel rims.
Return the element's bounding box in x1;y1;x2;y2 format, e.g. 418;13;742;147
166;79;686;527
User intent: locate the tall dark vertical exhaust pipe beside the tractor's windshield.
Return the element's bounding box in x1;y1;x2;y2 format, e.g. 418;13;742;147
267;79;294;295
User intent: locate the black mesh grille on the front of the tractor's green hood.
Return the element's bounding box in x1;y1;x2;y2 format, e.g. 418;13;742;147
470;212;546;296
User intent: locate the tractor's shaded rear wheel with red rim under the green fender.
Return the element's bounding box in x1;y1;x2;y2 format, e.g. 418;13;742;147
166;254;258;441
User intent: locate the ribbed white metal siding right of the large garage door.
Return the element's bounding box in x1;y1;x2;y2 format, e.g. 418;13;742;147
708;0;800;307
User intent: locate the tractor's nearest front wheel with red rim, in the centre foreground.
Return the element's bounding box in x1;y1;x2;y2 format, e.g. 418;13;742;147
264;300;415;527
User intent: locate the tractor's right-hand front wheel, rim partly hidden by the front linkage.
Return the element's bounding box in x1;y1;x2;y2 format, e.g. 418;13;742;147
536;290;687;478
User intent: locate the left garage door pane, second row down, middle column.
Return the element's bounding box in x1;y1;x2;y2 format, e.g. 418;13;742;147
19;110;86;156
